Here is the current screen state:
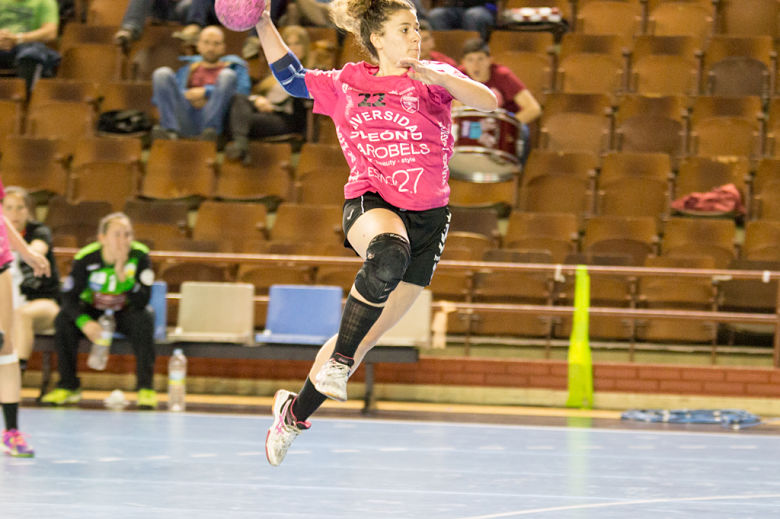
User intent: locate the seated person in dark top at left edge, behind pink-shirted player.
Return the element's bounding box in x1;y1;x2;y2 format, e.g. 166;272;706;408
3;186;60;371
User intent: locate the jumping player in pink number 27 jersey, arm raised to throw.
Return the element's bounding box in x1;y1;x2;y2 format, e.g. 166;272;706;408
257;0;497;465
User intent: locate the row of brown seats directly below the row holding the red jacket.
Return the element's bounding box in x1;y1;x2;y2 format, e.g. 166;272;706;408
45;188;780;268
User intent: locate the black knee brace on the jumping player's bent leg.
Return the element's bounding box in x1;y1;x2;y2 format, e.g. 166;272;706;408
355;233;412;304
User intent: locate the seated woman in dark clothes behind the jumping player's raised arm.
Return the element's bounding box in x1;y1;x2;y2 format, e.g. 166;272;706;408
225;25;316;164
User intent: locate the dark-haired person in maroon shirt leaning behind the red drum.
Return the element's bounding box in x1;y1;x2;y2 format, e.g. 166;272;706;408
460;38;542;164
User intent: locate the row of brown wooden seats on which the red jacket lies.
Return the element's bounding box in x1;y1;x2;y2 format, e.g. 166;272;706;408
450;149;780;222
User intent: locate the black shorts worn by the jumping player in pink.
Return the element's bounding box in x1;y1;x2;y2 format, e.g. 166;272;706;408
341;192;450;287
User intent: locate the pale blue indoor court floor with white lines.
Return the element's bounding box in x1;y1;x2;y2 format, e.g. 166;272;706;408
0;408;780;519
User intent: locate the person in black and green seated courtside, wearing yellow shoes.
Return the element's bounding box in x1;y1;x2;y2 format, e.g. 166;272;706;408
41;213;157;409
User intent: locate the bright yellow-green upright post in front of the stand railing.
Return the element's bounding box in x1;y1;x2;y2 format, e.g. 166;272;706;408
566;265;593;409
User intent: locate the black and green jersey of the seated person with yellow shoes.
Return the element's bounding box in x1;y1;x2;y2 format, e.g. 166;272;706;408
61;241;154;328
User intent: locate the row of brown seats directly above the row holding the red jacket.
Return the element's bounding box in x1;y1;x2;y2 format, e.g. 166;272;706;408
537;94;780;165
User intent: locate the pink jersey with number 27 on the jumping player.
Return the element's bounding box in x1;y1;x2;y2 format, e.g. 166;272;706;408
306;62;463;211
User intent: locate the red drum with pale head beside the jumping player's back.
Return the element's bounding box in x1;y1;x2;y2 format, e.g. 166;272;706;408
450;107;521;182
